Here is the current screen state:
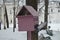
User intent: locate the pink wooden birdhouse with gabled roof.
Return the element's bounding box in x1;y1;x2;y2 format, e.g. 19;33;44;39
17;6;38;31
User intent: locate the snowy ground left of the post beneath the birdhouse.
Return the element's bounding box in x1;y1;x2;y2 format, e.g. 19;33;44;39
0;24;27;40
